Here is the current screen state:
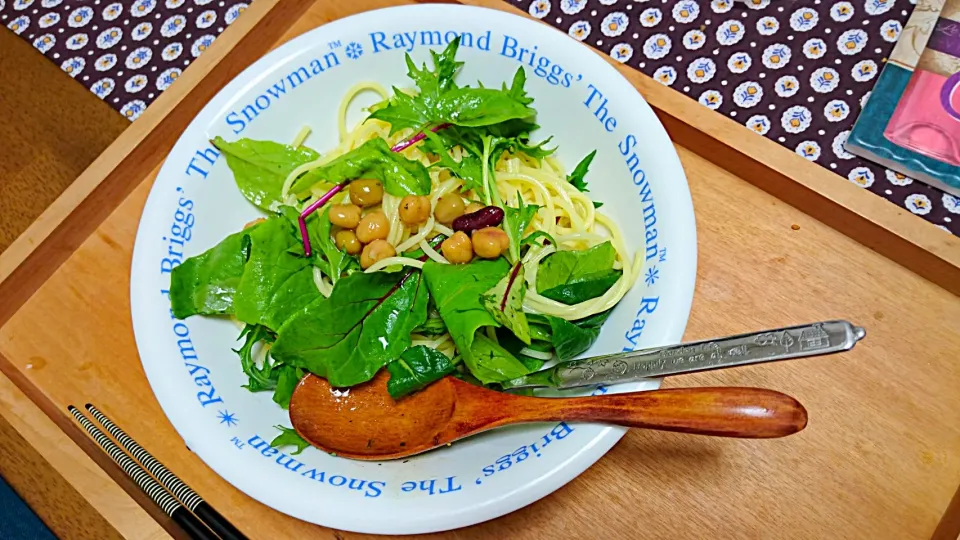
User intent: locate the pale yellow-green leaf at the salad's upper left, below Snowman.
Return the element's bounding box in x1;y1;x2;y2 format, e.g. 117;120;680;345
211;137;320;212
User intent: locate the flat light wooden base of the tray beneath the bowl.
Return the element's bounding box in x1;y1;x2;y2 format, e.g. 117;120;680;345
0;0;960;539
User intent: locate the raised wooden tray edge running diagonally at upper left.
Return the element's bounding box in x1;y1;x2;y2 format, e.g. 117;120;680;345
0;0;310;324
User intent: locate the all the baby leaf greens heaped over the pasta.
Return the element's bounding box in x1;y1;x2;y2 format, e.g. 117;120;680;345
170;39;622;418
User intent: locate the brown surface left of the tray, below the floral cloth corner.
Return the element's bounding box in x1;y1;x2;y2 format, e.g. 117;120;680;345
0;27;130;253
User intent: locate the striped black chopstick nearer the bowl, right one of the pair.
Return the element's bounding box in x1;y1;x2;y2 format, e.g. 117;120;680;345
86;403;247;540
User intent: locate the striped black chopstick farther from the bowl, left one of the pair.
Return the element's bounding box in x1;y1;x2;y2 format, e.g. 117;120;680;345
67;405;218;540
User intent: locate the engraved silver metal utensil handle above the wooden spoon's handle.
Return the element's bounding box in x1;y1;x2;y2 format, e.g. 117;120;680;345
504;321;866;388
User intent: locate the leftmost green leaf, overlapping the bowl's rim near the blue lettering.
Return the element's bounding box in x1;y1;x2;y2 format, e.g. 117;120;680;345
170;227;249;319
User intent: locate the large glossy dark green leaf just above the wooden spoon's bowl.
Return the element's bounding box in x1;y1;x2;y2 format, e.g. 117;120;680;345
271;271;428;387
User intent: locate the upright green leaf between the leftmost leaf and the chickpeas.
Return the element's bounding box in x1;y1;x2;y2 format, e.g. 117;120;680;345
234;216;322;331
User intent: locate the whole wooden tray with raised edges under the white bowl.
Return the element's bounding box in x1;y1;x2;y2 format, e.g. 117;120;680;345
0;0;960;538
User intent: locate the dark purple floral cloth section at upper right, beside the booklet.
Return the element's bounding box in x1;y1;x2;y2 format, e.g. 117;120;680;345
507;0;960;234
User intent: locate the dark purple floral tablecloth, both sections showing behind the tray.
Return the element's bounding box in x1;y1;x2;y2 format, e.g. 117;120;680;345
0;0;960;234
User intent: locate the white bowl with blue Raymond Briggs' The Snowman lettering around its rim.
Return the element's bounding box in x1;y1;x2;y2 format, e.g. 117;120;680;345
130;5;696;534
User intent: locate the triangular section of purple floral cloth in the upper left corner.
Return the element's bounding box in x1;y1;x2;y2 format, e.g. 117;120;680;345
0;0;248;120
